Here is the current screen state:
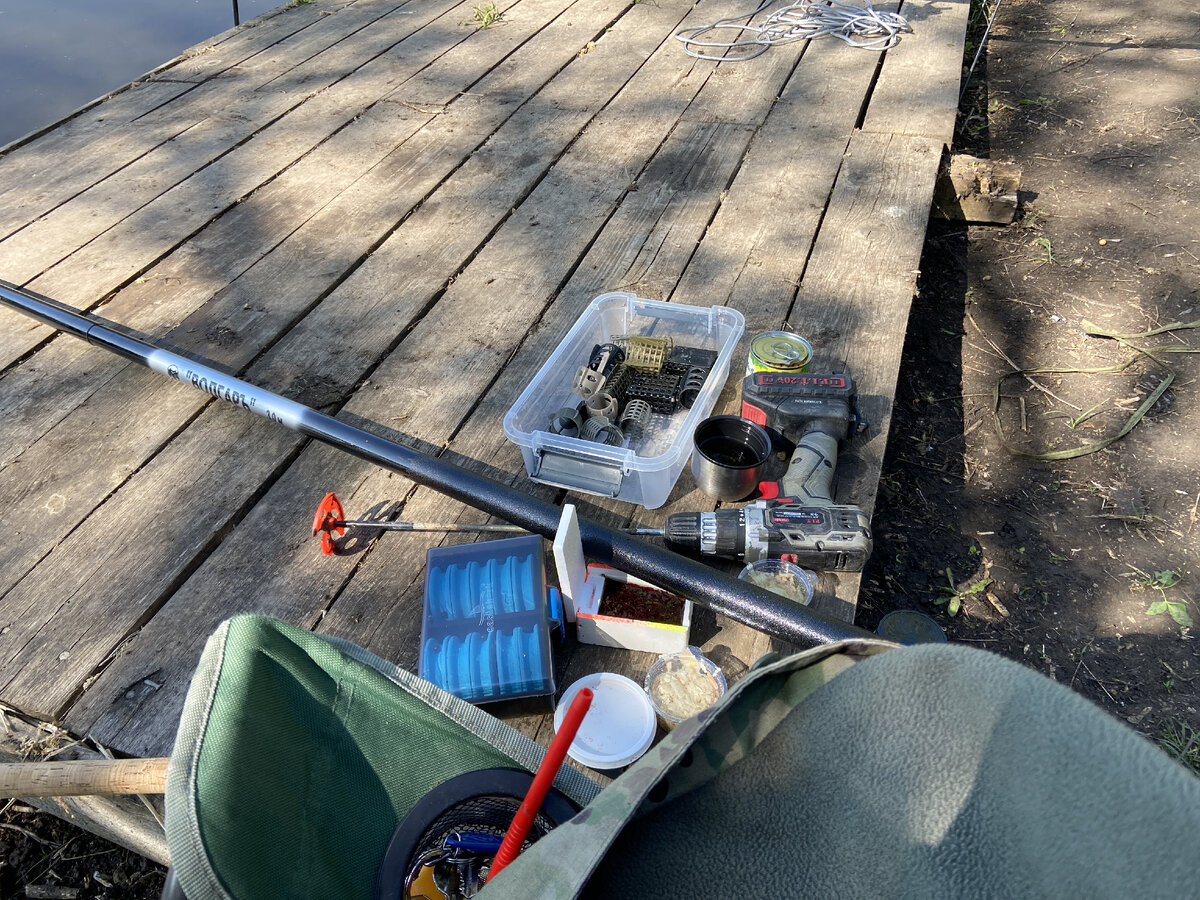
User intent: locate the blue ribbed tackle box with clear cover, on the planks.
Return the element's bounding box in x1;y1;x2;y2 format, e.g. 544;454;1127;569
418;535;563;703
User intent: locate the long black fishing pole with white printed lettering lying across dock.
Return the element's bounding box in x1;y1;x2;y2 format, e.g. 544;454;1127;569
0;280;874;647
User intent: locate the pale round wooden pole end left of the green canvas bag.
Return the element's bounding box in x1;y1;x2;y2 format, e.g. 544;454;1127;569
0;757;168;799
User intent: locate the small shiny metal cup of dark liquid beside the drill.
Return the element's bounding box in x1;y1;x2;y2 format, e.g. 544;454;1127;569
691;415;770;500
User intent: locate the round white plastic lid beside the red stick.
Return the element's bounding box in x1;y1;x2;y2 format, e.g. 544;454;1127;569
554;672;658;769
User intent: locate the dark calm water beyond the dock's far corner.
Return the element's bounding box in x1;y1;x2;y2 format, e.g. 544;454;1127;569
0;0;281;146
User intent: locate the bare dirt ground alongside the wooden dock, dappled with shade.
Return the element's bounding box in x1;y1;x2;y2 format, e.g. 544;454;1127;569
0;0;1200;900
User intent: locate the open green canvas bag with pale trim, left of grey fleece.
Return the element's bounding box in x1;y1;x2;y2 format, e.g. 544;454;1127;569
166;616;600;900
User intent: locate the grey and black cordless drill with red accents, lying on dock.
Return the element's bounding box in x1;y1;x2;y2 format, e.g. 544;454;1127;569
664;372;871;572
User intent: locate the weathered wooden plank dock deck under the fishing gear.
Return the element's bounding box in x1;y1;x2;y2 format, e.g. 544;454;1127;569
0;0;967;854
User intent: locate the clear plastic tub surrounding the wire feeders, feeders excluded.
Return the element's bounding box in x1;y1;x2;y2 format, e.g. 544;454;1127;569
504;292;745;509
